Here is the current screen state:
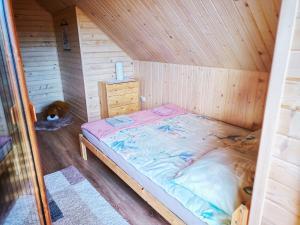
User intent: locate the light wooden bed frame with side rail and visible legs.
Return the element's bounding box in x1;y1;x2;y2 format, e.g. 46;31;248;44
79;134;249;225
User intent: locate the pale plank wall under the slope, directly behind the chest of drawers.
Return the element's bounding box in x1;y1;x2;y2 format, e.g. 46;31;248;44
76;7;133;121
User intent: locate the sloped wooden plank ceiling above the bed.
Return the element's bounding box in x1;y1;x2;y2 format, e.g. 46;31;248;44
40;0;280;71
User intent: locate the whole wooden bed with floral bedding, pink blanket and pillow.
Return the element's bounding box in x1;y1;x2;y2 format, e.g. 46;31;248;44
80;104;259;225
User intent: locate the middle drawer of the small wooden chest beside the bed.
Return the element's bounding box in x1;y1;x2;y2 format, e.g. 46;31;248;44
107;93;139;108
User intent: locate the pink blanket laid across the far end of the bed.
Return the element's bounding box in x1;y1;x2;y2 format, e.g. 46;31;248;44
81;104;186;140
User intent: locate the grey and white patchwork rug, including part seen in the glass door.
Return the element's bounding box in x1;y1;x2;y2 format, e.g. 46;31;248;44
4;166;128;225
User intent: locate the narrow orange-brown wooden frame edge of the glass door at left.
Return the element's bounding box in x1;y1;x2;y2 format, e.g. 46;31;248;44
0;0;52;225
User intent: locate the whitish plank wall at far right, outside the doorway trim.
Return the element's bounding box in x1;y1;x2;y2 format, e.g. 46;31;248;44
263;4;300;225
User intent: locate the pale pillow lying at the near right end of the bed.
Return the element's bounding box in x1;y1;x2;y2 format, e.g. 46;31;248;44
174;149;255;215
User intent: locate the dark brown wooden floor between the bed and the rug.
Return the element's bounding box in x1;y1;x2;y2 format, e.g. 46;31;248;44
37;116;168;225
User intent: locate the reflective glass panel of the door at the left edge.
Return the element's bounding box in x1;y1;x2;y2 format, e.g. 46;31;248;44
0;3;43;225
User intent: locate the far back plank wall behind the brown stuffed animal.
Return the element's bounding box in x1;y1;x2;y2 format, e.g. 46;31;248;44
13;0;63;112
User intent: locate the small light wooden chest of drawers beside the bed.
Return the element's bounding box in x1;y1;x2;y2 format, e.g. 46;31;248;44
99;80;140;118
